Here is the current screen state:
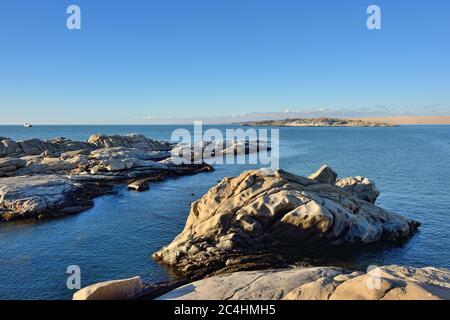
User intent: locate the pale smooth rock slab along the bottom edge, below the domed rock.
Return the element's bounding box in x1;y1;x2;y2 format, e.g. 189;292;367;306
158;266;450;300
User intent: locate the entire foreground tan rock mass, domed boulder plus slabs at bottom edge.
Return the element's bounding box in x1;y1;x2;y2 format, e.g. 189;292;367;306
74;166;450;300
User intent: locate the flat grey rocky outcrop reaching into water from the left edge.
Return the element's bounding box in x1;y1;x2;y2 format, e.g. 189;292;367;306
0;134;261;222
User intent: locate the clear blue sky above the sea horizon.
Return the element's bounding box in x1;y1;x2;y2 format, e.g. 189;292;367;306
0;0;450;124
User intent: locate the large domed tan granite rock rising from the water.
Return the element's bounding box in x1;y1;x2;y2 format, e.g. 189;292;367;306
153;170;419;276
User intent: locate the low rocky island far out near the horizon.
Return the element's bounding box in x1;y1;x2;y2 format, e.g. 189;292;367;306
239;118;398;127
